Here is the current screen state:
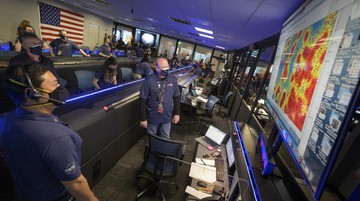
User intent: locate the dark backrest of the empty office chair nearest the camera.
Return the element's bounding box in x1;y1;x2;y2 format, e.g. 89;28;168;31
144;134;186;177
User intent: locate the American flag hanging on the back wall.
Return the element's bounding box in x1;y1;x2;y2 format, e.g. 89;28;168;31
39;2;84;44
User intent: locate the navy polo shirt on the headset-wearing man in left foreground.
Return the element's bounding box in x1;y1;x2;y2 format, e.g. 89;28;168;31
0;108;82;201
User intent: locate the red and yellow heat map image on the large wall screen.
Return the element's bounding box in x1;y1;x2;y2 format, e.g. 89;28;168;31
273;12;338;131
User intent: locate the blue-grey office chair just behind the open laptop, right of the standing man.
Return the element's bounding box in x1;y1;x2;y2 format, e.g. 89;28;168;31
190;95;219;134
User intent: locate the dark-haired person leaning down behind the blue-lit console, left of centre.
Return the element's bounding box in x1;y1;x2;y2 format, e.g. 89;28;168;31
93;57;117;89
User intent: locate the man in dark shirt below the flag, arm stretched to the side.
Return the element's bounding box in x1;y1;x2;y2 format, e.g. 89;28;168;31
49;30;90;57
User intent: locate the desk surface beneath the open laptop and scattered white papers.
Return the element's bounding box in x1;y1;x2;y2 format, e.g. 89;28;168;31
189;143;229;200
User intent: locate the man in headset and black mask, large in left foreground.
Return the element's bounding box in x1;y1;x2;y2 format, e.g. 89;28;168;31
0;63;98;201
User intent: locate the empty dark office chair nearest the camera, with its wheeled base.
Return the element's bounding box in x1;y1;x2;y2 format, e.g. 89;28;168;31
135;134;186;201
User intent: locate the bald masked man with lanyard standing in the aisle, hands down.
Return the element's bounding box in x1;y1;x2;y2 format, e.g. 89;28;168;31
140;58;180;139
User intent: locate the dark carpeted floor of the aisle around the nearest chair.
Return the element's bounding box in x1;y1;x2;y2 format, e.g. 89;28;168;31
93;104;229;201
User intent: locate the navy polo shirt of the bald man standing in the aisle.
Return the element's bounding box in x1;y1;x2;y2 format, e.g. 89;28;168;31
140;73;180;124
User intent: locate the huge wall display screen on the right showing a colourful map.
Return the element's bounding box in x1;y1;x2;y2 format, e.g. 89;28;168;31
266;0;360;198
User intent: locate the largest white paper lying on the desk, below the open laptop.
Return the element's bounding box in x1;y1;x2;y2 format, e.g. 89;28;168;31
189;162;216;183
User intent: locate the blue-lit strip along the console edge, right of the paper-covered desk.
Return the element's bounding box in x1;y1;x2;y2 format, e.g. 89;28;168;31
234;121;261;201
